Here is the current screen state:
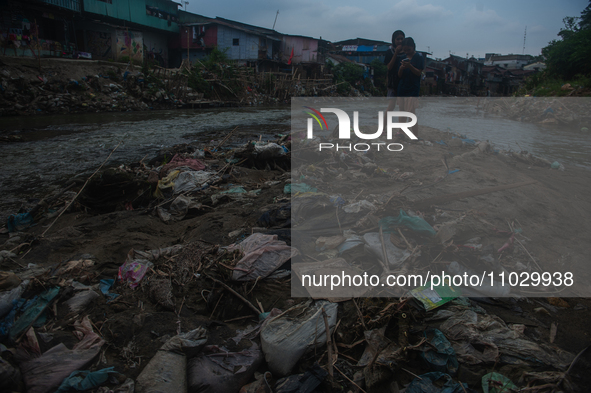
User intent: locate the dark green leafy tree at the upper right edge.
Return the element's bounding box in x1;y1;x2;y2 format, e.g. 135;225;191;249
542;2;591;80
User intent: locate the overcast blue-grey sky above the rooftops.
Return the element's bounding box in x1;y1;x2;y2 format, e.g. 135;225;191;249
183;0;589;59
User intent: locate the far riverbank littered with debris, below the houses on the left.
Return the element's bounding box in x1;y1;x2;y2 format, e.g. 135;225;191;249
0;56;362;116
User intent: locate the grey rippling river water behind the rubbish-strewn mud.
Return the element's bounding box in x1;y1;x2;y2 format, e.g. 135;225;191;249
0;100;591;221
